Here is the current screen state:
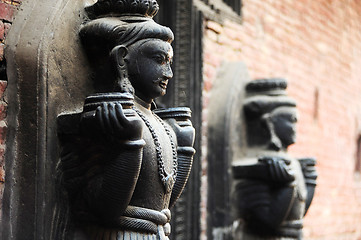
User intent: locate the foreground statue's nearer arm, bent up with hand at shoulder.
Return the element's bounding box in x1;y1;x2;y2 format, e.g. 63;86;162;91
79;103;145;224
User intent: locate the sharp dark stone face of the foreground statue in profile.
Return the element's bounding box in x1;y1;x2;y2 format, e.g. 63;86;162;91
126;39;173;103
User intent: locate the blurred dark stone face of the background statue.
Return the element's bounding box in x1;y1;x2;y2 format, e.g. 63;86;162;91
271;107;297;147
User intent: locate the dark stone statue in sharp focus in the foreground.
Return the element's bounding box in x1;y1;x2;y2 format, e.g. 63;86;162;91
58;0;195;240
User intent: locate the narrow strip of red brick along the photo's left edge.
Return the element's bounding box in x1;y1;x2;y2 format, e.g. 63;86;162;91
0;0;22;217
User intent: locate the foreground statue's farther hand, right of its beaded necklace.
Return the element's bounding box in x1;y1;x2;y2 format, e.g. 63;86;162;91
166;118;195;147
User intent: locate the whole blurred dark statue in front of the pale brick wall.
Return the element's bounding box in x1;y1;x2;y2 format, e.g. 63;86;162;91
232;79;317;239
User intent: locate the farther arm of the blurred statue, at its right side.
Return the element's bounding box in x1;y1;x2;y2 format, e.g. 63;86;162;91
298;158;318;214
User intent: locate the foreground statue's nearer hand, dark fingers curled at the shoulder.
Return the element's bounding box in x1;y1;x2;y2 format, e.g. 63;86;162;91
95;103;143;141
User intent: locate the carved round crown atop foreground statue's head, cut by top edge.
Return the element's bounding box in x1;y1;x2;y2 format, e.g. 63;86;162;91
85;0;159;19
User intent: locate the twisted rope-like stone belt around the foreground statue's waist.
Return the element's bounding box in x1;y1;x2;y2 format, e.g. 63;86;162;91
118;206;171;236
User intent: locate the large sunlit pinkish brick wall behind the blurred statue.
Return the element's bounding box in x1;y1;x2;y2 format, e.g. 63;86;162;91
203;0;361;240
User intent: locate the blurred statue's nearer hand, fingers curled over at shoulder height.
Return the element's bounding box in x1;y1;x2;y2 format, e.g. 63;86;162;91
258;157;295;183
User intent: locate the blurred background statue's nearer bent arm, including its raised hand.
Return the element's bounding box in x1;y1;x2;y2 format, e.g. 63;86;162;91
233;157;295;231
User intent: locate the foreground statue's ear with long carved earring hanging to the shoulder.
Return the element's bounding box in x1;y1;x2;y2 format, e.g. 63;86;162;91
110;45;134;95
